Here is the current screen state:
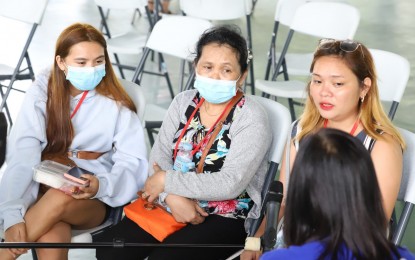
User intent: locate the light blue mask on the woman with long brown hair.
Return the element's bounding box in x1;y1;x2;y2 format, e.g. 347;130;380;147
65;64;106;91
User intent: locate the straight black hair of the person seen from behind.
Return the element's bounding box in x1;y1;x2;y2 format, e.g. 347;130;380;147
284;128;399;259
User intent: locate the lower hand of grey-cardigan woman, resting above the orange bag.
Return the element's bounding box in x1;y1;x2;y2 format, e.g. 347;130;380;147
166;194;209;225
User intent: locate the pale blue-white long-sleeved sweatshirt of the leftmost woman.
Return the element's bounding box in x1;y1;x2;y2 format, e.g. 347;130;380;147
0;71;148;230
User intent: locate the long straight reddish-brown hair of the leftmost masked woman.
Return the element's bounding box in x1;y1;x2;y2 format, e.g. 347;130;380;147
42;23;137;155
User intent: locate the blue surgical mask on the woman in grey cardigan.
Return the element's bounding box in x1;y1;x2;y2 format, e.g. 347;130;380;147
194;74;240;104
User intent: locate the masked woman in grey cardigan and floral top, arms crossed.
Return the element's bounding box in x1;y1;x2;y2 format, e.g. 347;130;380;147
97;26;271;259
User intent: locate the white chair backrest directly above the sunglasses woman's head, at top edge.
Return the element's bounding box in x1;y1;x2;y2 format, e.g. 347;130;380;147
290;2;360;39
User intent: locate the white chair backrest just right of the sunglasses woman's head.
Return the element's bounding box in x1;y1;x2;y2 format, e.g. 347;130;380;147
370;49;411;119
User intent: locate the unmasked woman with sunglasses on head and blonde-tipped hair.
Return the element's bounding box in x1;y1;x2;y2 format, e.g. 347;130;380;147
243;39;405;259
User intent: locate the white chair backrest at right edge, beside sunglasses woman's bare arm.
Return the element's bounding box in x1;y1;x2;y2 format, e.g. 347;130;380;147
398;128;415;204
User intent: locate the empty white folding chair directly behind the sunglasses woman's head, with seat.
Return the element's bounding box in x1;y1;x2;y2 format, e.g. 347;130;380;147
255;2;360;120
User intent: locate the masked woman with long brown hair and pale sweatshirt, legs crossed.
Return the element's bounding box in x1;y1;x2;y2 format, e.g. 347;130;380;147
0;23;148;260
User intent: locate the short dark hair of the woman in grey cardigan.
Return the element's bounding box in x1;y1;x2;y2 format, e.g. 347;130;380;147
194;24;250;72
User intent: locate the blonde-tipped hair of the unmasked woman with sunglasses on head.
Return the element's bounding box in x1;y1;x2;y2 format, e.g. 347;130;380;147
296;38;405;149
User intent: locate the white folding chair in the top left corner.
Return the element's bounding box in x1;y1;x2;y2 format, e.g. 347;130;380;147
0;0;48;126
